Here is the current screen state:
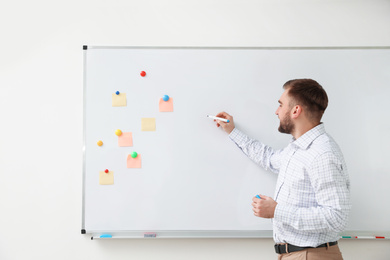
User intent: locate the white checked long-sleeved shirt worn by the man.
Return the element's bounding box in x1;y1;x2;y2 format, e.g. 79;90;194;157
229;123;351;247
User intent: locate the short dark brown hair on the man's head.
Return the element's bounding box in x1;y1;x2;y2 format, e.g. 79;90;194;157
283;79;328;121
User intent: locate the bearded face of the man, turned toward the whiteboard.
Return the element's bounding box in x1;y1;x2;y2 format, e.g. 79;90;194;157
275;90;295;134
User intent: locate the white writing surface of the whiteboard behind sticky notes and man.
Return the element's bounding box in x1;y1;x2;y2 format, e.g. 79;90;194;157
82;46;390;237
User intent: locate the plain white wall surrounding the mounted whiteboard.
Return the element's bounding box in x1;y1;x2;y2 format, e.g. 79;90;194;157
0;0;390;260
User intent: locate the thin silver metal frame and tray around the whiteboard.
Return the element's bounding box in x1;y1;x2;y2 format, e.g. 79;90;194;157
81;45;390;240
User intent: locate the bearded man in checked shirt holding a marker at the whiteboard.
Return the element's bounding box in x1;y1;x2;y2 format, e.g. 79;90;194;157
216;79;351;260
